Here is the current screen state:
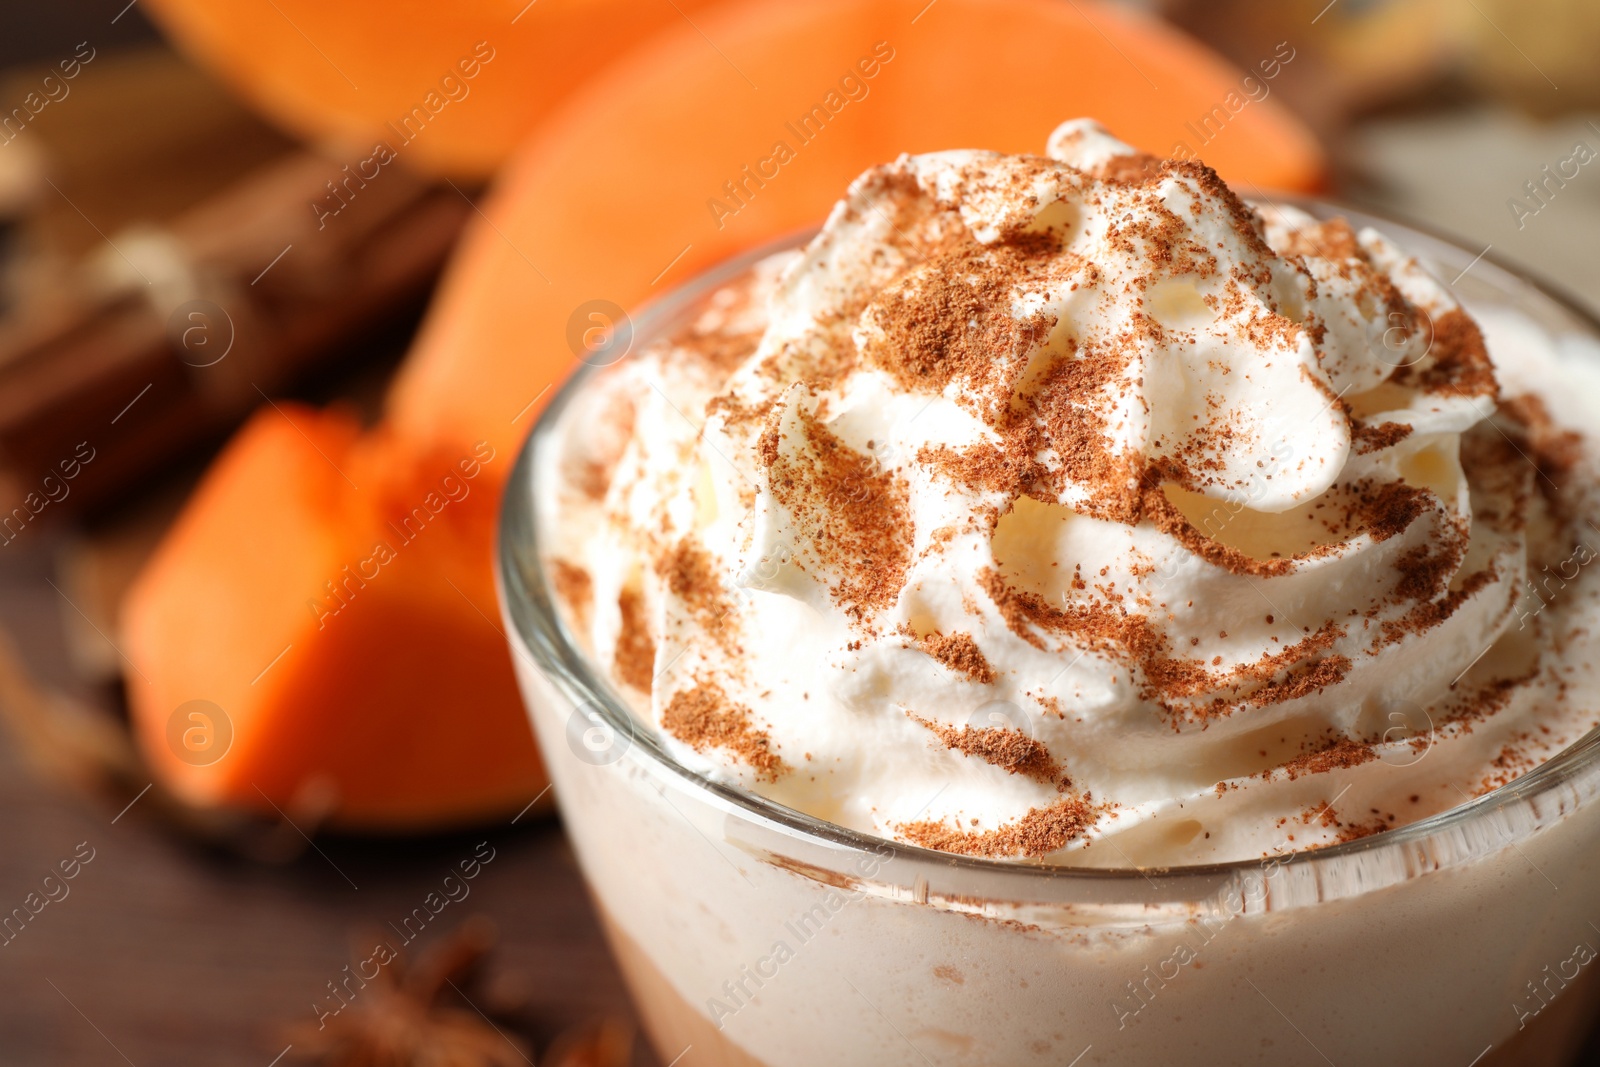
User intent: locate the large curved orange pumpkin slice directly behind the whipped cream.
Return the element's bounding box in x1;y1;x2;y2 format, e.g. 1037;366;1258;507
390;0;1323;448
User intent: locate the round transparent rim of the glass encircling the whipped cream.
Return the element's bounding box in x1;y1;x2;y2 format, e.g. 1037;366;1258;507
494;194;1600;891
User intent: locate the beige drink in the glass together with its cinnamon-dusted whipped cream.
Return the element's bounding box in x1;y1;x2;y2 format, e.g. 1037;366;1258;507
507;122;1600;1067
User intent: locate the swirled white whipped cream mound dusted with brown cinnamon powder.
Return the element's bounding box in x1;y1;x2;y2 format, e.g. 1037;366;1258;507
547;120;1594;865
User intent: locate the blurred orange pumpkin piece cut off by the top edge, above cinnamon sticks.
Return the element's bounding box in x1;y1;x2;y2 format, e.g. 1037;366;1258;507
147;0;723;178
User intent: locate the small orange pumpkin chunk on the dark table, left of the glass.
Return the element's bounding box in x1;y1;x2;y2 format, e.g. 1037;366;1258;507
123;405;544;830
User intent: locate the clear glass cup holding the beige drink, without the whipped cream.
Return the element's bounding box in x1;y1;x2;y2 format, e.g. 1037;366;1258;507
498;202;1600;1067
